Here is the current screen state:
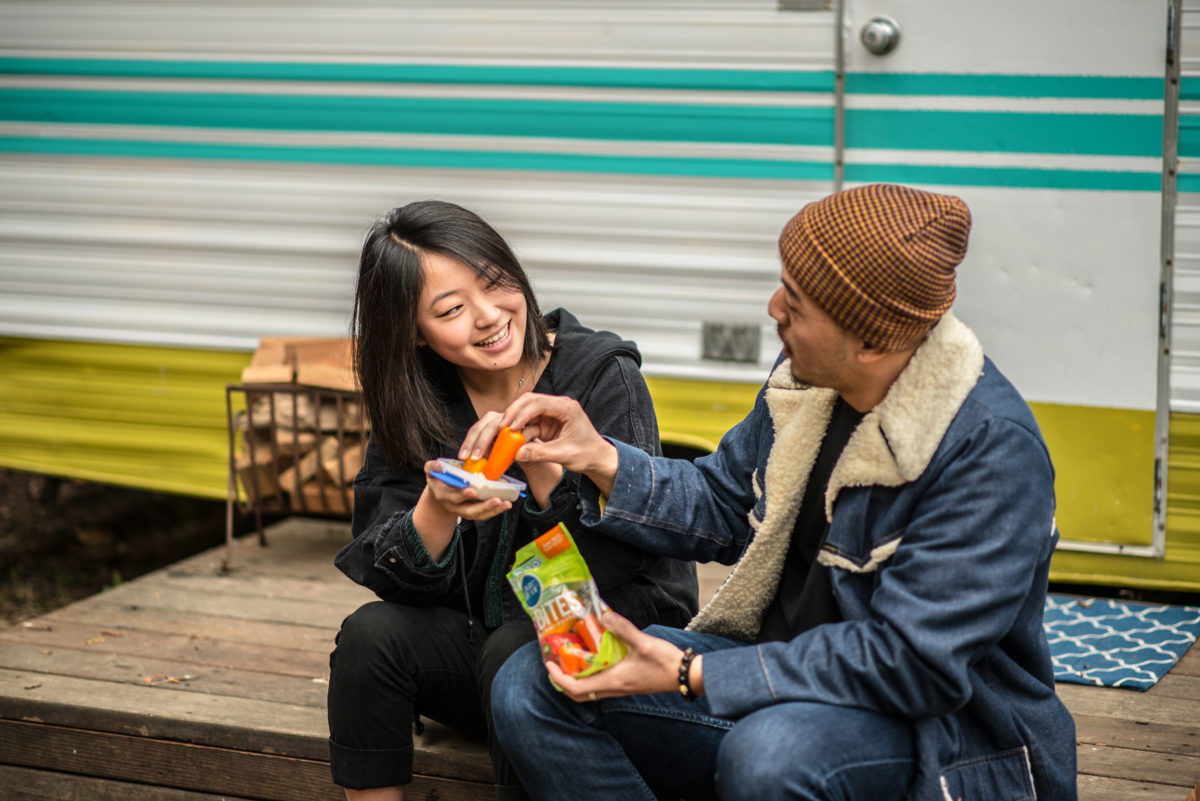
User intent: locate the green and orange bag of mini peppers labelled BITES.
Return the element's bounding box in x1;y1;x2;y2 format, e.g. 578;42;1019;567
508;523;628;676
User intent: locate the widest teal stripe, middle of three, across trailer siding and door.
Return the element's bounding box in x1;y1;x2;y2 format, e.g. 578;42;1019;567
0;89;1163;157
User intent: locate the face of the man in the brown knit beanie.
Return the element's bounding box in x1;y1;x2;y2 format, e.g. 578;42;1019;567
767;270;862;391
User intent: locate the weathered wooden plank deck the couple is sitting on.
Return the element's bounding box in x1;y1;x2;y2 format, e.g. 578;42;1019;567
0;518;1200;801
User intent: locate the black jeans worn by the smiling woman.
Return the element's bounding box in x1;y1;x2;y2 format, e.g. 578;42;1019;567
329;601;536;799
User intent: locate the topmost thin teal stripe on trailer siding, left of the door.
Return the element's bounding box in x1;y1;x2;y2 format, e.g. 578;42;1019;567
0;58;834;94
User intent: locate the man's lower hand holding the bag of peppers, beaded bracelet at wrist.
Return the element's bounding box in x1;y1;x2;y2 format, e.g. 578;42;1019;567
546;612;702;701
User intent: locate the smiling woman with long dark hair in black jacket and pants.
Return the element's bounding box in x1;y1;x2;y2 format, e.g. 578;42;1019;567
329;200;697;799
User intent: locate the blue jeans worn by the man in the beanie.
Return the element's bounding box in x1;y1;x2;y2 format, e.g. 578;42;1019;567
492;626;914;801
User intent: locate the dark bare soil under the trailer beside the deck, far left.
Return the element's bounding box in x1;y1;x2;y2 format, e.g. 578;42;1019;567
0;470;236;625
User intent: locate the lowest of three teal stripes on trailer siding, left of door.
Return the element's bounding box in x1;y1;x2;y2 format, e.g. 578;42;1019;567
0;135;833;181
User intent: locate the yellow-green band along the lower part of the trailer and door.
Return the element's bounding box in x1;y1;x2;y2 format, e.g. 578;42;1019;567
0;338;1200;590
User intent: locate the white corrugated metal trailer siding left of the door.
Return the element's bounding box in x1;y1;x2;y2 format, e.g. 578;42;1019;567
0;0;833;381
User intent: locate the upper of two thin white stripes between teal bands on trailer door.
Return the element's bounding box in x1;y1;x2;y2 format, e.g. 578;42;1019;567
846;92;1163;115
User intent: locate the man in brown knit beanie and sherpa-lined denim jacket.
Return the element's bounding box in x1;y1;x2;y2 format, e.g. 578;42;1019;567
492;185;1076;801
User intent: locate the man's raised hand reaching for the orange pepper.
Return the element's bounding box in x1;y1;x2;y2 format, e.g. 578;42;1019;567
502;392;617;495
